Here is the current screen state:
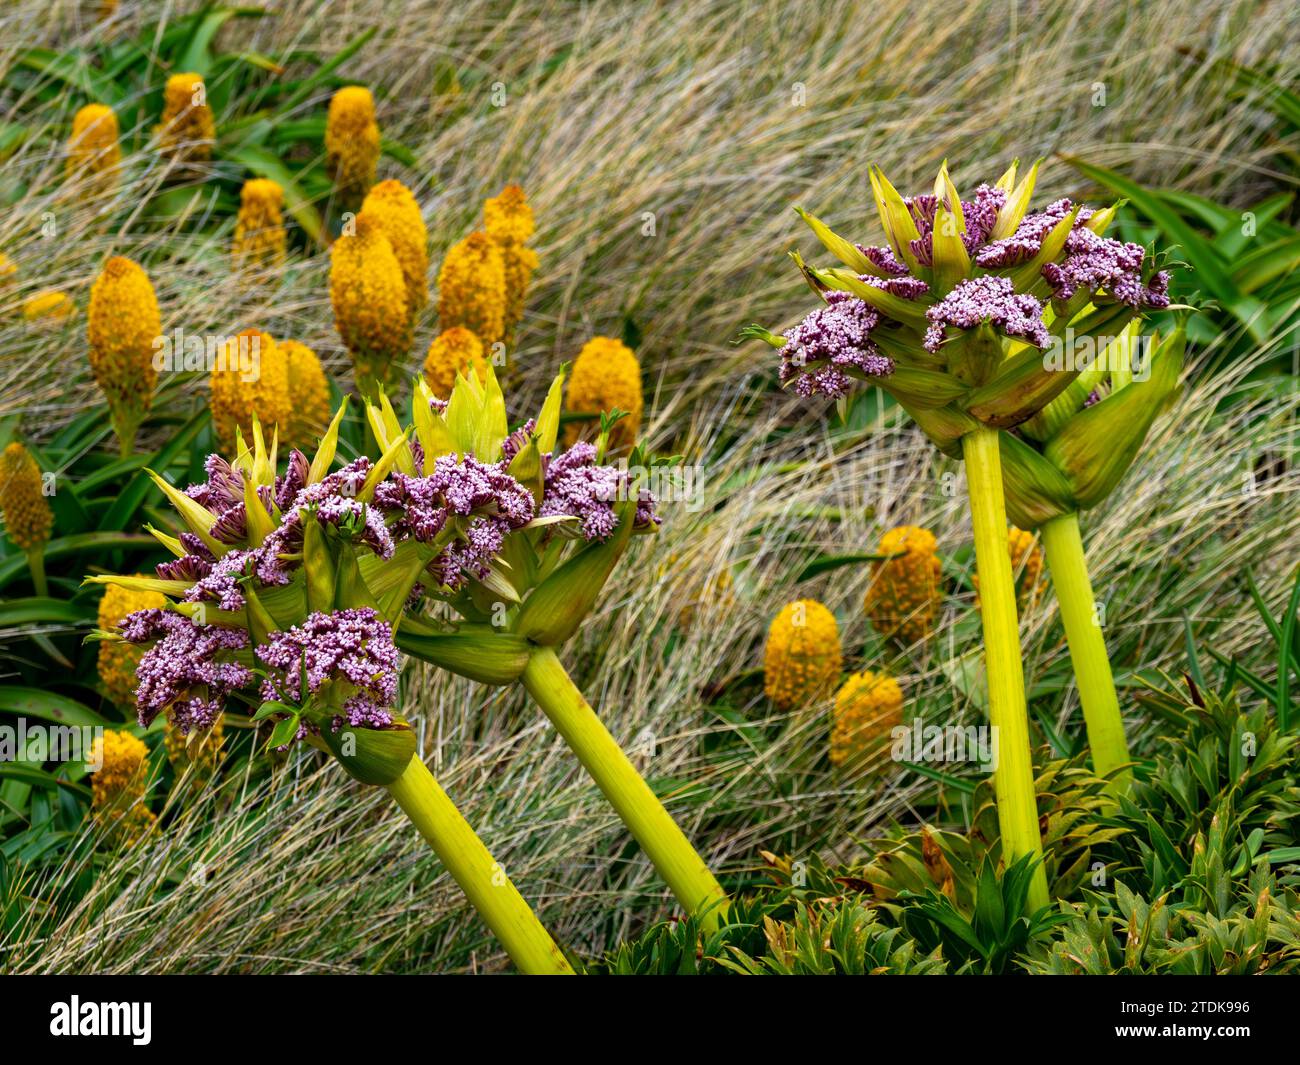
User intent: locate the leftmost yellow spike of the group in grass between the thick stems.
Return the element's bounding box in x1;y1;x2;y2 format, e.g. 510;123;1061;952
763;599;844;710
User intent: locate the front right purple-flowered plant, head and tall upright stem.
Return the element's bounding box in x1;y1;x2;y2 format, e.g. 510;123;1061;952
745;164;1169;909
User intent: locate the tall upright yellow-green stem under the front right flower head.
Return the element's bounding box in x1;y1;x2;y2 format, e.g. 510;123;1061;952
962;428;1048;910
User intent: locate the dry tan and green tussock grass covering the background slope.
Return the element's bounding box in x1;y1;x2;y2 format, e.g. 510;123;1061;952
0;0;1300;973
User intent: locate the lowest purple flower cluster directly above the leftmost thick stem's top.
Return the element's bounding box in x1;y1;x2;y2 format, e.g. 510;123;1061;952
257;607;400;728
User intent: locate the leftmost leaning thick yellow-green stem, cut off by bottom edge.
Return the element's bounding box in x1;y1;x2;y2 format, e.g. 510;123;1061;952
389;757;573;975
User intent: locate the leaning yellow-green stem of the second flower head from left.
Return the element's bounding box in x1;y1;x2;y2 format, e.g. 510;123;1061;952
521;648;727;930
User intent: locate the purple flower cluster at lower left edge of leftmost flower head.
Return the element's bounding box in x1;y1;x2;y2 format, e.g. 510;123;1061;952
122;610;252;733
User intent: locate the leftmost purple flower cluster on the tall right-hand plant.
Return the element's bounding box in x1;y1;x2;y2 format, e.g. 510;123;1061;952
780;291;894;397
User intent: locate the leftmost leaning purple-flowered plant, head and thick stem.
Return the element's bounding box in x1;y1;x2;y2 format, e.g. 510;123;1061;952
90;416;572;974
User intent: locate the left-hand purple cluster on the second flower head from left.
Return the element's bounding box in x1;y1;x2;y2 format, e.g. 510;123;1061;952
374;455;536;589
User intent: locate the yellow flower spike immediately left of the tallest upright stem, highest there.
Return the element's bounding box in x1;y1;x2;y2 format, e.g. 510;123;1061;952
863;525;944;646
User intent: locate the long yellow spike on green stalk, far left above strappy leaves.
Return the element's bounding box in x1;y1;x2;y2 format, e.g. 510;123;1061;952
86;255;163;456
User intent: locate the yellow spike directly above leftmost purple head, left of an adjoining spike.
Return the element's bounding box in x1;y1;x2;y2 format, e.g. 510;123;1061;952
208;329;295;453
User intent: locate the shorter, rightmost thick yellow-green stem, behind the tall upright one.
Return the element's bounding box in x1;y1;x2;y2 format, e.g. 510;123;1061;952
1040;514;1131;791
